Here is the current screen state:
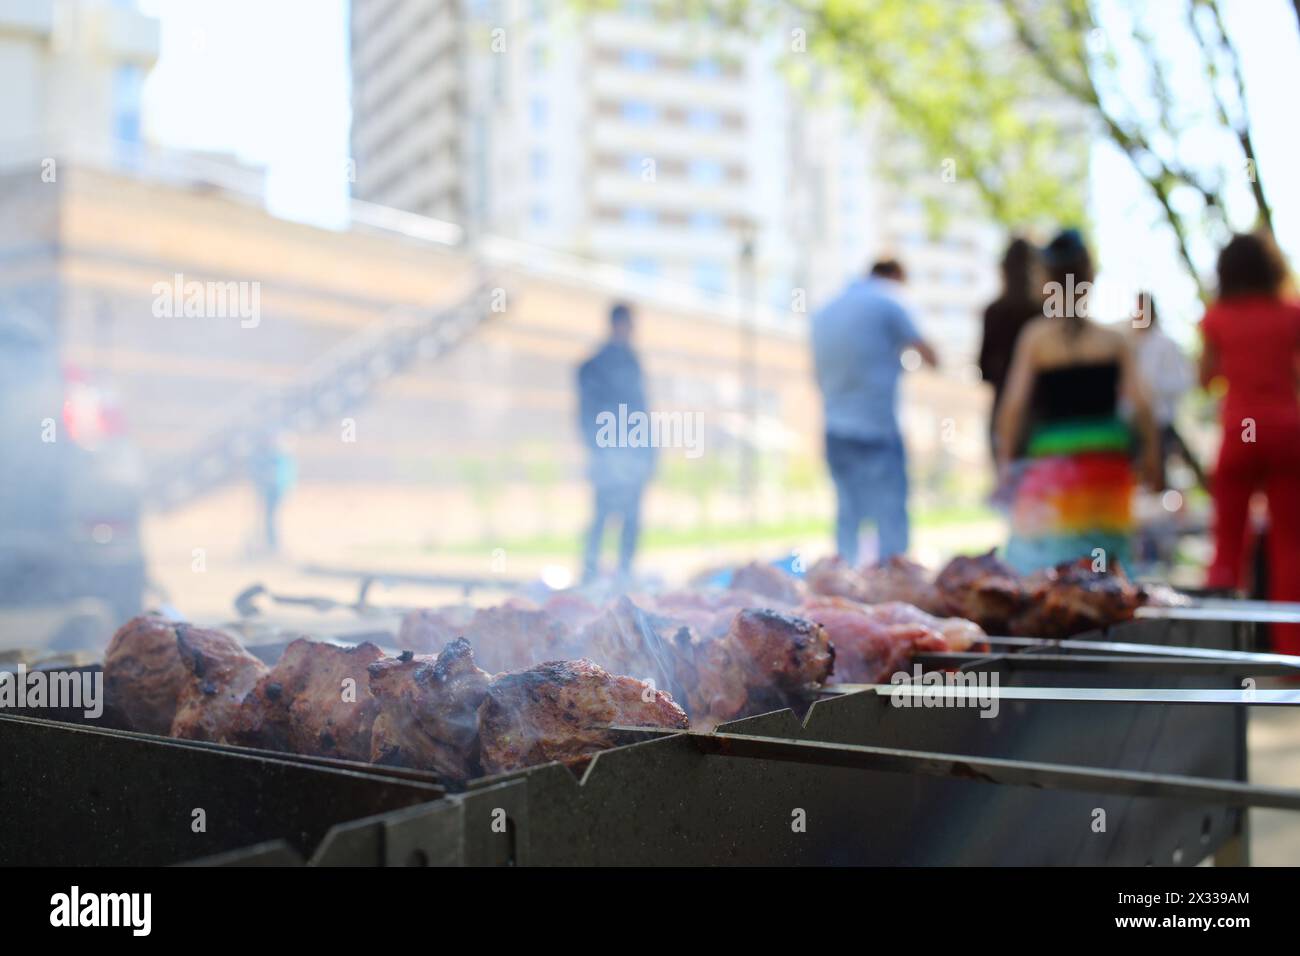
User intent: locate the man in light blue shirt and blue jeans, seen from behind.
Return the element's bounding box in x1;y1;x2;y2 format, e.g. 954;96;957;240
813;259;937;564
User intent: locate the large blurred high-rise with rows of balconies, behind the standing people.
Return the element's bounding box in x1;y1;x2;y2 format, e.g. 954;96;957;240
351;0;1000;363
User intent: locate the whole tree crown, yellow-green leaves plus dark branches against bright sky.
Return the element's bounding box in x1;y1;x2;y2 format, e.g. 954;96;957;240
629;0;1279;298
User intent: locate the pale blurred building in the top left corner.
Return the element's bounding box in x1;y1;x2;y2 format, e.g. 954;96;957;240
0;0;159;163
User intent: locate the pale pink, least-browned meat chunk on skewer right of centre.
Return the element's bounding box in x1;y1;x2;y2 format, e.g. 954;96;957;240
800;597;984;684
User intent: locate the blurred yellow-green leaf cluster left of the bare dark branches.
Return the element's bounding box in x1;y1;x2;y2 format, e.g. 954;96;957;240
788;0;1088;228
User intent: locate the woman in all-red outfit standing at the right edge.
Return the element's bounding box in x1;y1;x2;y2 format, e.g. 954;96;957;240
1201;235;1300;654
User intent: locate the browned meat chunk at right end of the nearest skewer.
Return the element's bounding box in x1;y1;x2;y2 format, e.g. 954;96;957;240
478;659;686;774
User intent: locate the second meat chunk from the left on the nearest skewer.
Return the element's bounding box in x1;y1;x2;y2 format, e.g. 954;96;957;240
172;624;267;743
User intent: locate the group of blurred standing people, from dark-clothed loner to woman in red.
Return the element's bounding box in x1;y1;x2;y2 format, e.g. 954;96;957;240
577;229;1300;653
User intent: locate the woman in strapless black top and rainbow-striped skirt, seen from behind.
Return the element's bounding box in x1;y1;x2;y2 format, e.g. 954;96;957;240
997;229;1157;574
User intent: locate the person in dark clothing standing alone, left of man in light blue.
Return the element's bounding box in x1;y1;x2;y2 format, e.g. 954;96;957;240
577;303;654;581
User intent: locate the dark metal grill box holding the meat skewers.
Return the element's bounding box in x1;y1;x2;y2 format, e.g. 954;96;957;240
0;604;1300;865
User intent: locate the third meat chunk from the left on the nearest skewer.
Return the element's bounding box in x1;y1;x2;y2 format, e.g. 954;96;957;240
233;637;384;761
